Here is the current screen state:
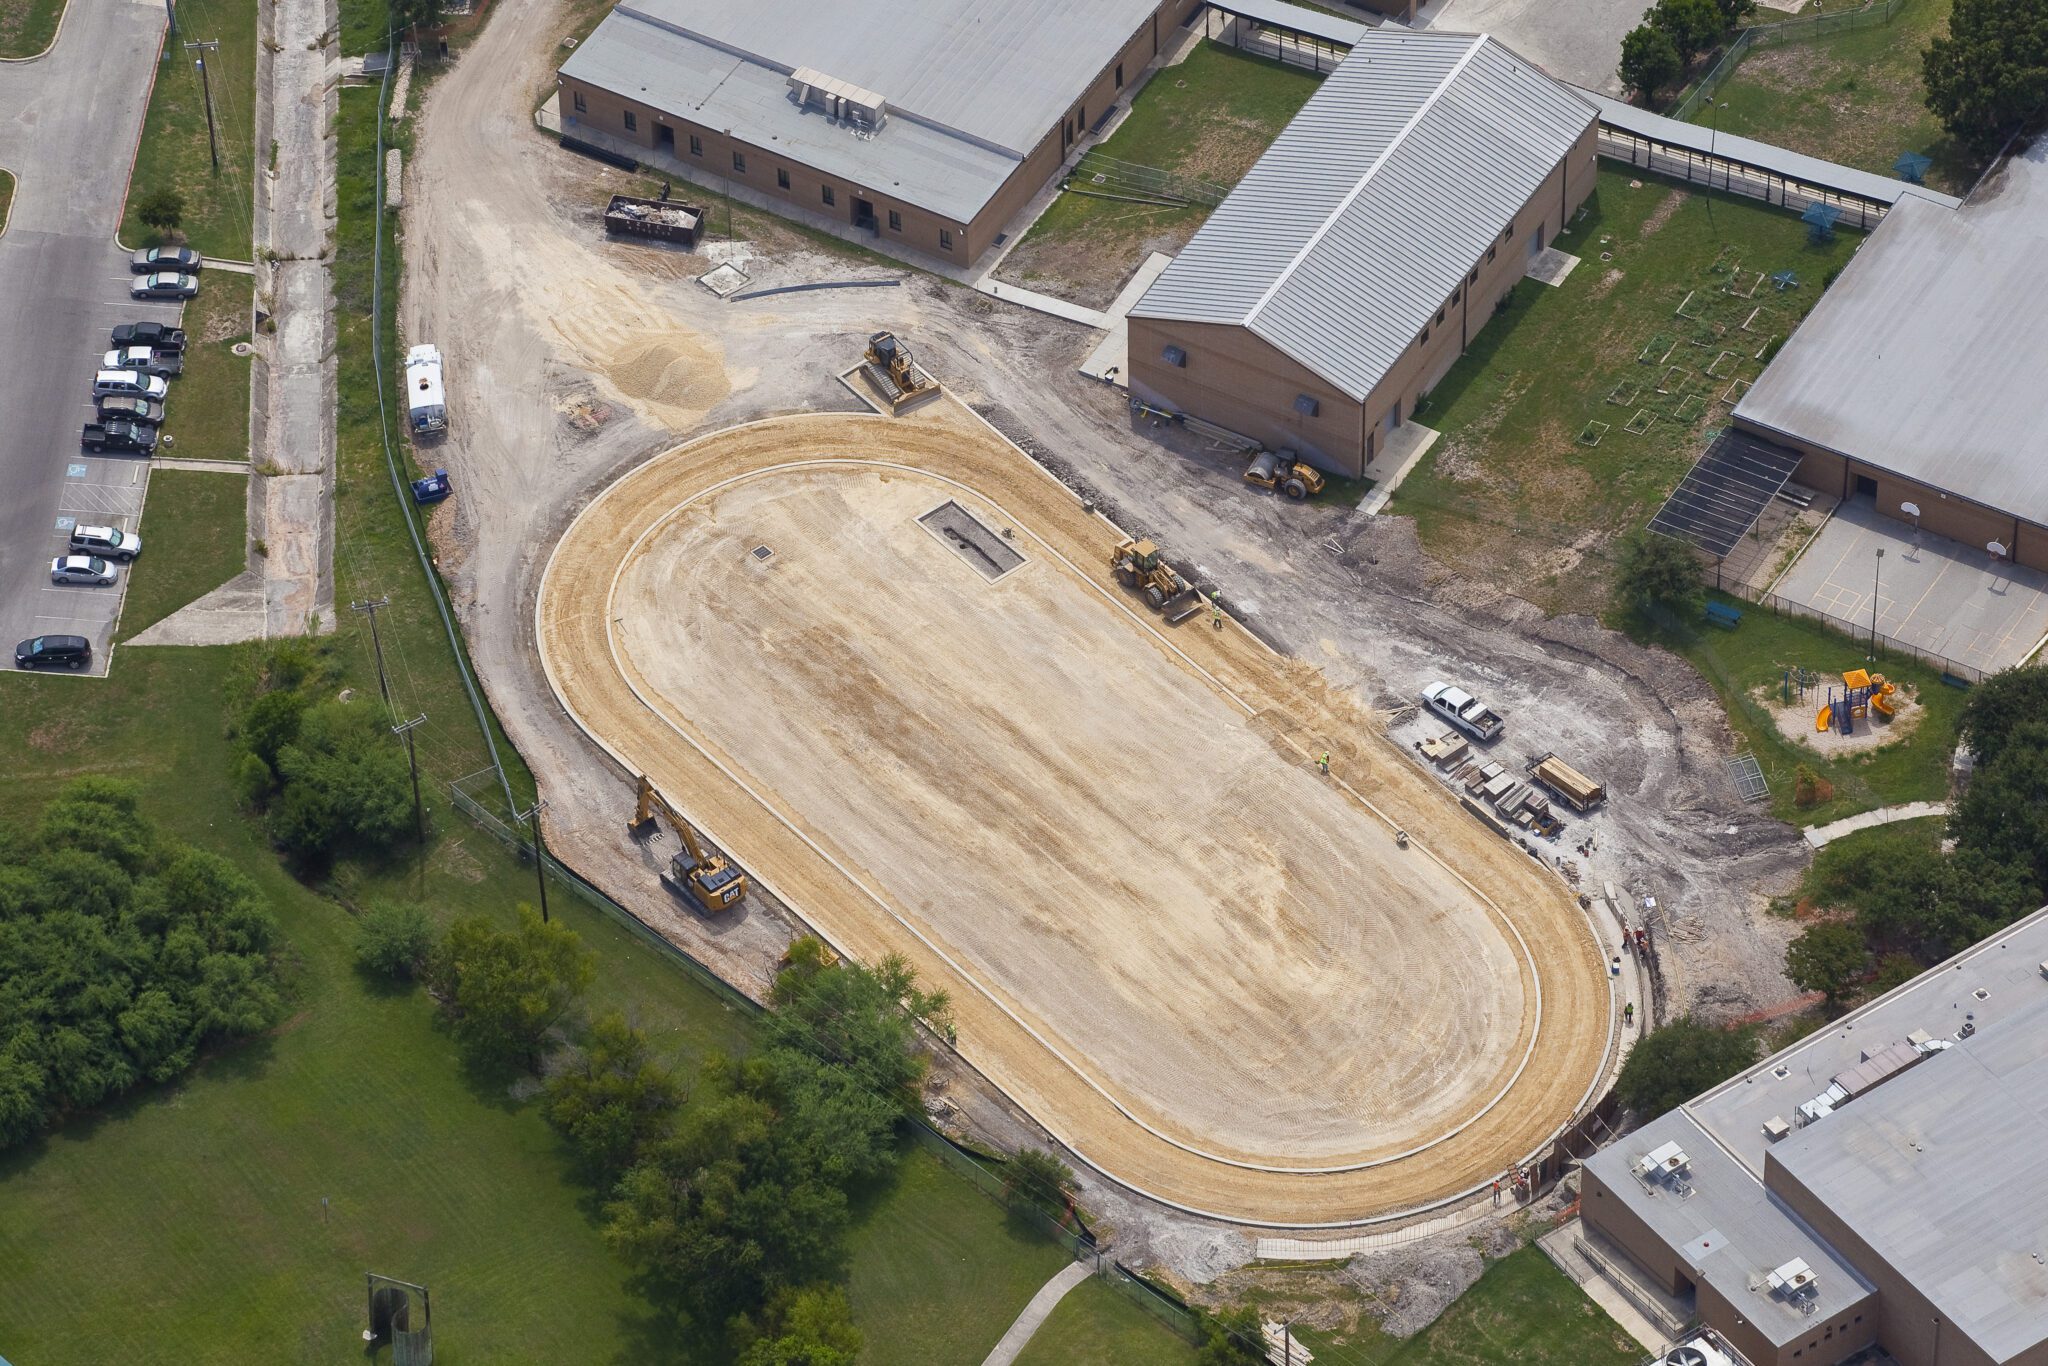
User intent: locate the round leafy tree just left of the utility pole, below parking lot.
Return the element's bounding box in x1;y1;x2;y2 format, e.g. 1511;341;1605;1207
270;702;412;858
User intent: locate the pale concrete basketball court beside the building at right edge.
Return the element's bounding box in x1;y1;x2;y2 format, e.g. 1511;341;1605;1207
1778;498;2048;674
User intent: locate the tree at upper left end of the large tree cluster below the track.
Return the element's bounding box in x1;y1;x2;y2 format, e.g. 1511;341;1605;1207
541;1010;682;1192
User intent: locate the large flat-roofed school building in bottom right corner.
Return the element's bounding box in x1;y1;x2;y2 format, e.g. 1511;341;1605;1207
1581;909;2048;1366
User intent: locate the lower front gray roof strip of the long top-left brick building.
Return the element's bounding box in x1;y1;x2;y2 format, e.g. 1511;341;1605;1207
561;6;1020;223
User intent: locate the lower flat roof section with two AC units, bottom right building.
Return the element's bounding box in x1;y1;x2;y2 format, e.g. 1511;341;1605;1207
1585;1110;1872;1346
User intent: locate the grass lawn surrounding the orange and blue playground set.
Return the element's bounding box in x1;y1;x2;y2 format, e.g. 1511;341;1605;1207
1622;594;1966;825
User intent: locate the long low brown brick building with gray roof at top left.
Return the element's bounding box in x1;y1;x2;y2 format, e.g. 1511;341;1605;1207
557;0;1202;266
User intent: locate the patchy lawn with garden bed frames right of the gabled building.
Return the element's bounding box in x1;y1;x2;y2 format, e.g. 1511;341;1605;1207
1391;166;1860;610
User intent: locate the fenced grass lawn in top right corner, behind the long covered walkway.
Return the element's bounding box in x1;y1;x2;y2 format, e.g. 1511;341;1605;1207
1694;0;1978;195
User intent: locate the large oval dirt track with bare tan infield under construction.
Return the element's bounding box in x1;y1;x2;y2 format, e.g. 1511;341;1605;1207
537;403;1612;1225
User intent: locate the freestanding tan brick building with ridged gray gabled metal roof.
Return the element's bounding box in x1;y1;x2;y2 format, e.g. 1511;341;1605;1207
1128;27;1595;475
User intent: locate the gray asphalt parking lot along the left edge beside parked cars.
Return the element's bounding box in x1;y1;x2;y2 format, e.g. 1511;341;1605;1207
0;4;182;674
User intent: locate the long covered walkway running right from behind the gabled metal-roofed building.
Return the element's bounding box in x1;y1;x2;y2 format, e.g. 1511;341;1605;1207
1581;90;1962;229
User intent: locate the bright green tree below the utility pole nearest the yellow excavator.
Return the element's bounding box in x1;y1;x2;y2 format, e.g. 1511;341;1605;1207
432;905;596;1069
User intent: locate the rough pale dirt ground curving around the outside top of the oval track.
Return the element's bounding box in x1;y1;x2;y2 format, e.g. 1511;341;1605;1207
401;0;1806;1264
